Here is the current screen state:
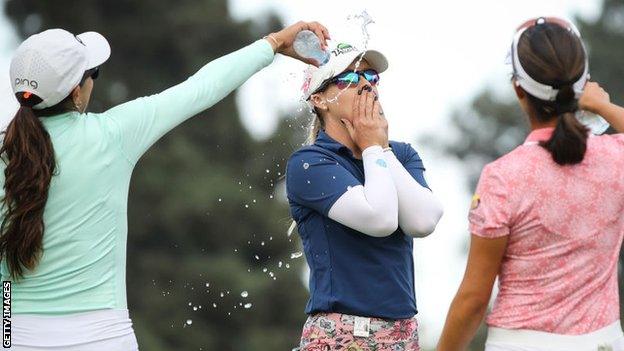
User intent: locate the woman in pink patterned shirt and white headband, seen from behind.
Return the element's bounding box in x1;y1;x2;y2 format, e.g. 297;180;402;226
438;18;624;351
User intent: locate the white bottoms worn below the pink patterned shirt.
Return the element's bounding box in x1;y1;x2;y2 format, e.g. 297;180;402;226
487;320;624;351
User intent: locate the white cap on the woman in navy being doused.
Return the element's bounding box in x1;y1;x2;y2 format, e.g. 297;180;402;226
302;43;388;100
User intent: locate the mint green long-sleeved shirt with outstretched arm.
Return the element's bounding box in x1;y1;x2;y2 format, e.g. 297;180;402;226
0;40;274;315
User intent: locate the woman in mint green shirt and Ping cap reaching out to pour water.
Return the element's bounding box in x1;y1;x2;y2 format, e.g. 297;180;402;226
0;22;328;351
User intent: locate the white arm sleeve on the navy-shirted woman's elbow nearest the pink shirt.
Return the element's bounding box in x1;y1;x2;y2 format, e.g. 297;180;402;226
384;151;444;238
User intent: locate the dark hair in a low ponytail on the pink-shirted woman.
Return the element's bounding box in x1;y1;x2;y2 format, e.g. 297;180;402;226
518;22;589;165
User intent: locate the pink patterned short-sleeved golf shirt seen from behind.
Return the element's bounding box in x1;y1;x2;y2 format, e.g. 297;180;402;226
469;128;624;335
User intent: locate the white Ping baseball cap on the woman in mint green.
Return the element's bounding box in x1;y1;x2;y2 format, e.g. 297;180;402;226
10;29;111;110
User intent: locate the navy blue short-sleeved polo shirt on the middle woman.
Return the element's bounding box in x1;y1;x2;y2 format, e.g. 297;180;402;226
286;131;427;319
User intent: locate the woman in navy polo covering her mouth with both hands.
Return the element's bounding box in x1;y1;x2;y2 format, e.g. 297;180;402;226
286;44;442;351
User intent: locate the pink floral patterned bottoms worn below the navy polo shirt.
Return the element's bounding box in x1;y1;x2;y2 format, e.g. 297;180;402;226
295;313;420;351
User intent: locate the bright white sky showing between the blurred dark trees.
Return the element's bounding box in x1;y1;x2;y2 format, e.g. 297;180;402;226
0;0;601;348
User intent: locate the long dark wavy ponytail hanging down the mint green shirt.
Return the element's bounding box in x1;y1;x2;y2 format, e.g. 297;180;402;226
0;93;56;279
